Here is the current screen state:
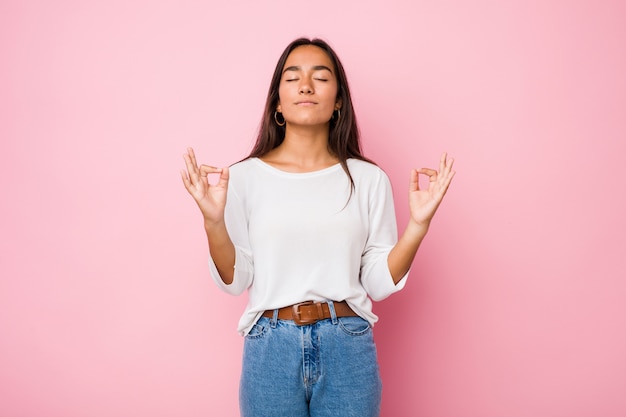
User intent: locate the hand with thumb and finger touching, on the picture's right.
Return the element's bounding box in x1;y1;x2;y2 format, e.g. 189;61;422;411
409;152;455;227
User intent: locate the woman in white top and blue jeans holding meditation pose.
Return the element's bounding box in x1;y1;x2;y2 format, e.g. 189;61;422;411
181;39;454;417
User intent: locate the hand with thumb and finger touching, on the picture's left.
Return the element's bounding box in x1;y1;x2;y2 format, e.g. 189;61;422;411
180;148;228;224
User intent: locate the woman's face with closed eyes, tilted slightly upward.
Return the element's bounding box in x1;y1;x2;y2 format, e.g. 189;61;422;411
276;45;341;126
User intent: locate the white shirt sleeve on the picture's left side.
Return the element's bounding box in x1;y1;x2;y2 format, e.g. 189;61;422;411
209;180;254;295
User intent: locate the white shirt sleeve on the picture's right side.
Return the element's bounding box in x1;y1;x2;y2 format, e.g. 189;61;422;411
361;170;409;301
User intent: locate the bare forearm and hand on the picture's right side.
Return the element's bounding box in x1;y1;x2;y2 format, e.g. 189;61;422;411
387;153;455;284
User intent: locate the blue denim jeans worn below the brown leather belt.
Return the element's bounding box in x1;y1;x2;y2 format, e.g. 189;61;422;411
239;303;382;417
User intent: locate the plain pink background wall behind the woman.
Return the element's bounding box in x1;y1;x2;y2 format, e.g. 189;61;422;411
0;0;626;417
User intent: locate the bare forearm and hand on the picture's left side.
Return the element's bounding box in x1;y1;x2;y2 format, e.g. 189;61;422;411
181;148;235;285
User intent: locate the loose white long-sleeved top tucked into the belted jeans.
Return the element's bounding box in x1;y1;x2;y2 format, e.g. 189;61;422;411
209;158;408;335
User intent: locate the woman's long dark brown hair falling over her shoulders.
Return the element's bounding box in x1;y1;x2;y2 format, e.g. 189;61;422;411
246;38;373;188
